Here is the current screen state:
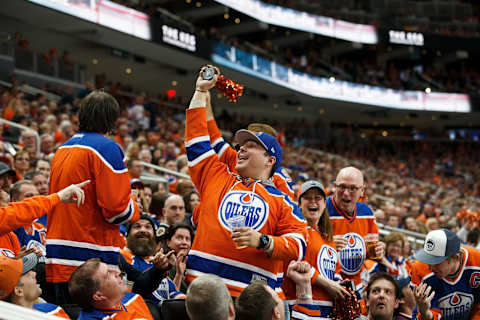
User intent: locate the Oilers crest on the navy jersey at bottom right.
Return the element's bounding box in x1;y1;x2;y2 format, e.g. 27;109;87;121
438;292;473;320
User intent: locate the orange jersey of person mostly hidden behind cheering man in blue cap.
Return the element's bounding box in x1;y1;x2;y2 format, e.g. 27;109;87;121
207;120;295;200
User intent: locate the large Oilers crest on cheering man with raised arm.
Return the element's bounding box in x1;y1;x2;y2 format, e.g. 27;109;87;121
218;191;269;231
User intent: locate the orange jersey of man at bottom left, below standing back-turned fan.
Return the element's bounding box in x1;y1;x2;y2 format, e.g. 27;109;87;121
78;292;153;320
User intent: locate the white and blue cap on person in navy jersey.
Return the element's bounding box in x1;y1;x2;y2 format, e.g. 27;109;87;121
415;229;461;265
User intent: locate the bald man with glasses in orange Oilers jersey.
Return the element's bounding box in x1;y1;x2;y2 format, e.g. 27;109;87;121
326;167;384;297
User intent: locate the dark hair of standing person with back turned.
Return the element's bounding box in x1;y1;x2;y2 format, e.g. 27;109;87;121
78;90;120;134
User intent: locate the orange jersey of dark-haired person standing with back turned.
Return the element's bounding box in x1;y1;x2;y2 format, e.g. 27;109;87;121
46;133;139;282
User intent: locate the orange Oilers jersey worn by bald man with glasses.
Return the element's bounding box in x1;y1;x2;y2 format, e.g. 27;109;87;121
326;197;378;293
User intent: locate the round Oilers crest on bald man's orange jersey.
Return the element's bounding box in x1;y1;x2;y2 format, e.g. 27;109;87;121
340;232;366;275
